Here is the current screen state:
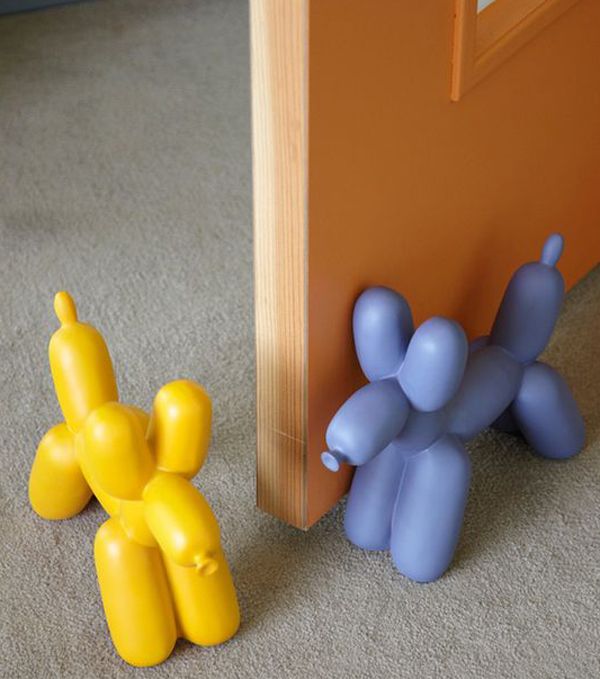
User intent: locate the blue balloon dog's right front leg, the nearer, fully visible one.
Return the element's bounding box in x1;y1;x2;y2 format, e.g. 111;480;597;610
391;435;471;582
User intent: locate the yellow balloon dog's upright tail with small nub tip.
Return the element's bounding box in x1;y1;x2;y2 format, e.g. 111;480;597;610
48;291;118;432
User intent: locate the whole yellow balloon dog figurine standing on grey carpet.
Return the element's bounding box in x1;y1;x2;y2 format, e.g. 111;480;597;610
29;292;240;666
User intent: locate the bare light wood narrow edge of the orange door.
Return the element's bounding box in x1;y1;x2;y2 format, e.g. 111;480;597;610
250;0;308;528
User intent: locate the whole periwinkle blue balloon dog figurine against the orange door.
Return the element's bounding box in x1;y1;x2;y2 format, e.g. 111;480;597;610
321;234;585;582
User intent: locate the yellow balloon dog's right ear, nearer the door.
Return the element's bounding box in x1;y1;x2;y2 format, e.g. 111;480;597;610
148;380;212;479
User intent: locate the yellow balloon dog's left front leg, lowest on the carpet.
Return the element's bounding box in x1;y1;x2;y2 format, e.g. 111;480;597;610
94;518;177;667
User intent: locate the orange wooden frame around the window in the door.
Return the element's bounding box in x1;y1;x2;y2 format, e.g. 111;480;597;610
450;0;578;101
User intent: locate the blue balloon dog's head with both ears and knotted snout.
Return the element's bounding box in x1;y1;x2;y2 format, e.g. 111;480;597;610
321;287;468;471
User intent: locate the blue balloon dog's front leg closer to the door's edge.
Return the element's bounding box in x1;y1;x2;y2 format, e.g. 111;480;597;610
344;441;406;549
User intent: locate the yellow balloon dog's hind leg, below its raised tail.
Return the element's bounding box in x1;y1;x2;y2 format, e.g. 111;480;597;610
29;423;92;519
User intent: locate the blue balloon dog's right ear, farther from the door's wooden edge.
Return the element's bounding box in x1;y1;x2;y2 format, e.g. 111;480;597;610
398;316;469;412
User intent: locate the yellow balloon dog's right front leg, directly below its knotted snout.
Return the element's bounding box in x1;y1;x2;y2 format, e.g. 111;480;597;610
163;547;240;646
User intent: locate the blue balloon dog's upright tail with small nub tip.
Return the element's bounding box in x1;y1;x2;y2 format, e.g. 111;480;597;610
489;233;564;364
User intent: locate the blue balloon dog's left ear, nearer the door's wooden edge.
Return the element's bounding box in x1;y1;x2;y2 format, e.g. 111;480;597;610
352;287;414;382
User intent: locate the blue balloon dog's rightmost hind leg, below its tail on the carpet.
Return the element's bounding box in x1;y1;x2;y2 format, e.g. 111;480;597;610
511;362;585;459
